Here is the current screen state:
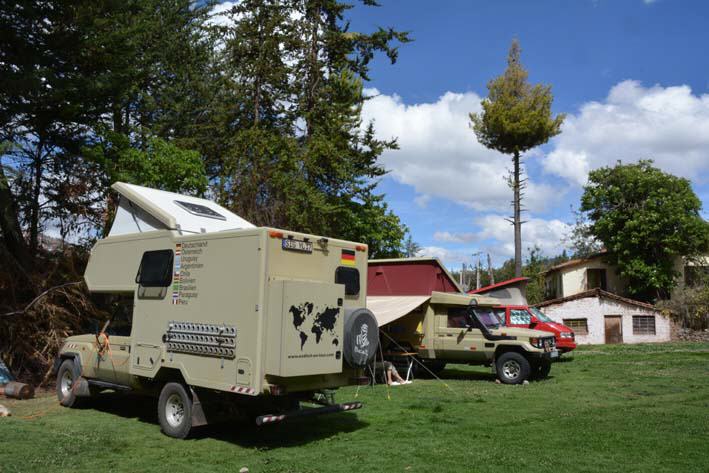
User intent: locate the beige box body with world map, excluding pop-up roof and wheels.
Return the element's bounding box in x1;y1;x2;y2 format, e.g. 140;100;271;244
82;228;366;395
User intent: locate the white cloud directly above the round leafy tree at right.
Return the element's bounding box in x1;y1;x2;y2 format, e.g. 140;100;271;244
543;80;709;185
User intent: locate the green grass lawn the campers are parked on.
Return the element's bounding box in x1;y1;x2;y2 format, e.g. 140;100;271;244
0;343;709;473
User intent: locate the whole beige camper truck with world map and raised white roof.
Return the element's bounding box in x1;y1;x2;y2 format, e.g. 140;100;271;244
55;183;379;438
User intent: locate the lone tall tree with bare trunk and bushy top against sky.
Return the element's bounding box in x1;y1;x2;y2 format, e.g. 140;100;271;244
470;40;564;277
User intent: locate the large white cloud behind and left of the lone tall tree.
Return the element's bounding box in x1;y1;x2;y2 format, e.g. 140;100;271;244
363;89;563;211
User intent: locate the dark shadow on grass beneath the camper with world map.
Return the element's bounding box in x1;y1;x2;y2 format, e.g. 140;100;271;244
80;392;369;450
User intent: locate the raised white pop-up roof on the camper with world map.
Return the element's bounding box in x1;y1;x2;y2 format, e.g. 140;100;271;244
109;182;254;236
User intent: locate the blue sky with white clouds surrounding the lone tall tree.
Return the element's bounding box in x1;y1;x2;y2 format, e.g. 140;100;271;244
349;0;709;269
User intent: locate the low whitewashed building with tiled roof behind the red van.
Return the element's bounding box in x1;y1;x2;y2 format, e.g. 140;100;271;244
537;288;672;344
